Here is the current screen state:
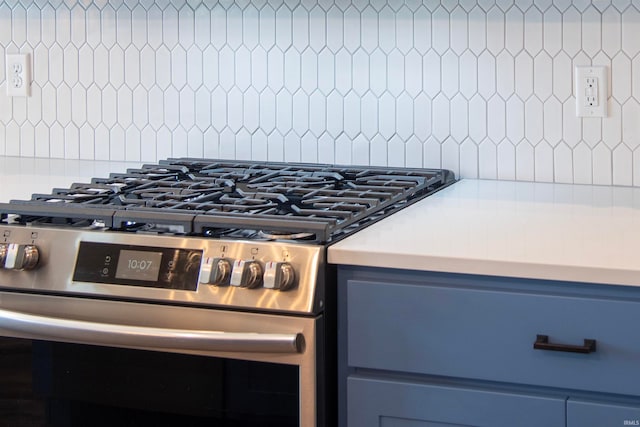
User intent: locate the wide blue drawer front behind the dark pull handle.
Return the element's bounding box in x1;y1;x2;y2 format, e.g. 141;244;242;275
347;280;640;395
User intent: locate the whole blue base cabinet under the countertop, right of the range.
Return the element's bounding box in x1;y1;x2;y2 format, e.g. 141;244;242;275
338;266;640;427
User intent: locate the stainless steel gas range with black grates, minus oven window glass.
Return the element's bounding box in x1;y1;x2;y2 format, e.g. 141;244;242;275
0;158;454;427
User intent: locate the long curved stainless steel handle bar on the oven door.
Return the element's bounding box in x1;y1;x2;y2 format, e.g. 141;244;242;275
0;309;304;353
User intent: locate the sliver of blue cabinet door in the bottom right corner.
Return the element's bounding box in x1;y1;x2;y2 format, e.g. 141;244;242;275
567;399;640;427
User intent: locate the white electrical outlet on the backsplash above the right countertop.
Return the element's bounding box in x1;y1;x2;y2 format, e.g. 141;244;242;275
575;66;609;117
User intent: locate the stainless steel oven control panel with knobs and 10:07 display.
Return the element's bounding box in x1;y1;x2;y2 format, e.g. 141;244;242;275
0;226;326;313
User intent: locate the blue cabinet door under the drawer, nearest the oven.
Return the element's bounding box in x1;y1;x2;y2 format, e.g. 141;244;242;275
347;377;565;427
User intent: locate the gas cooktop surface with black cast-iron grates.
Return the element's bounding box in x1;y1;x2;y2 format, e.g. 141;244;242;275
0;158;455;243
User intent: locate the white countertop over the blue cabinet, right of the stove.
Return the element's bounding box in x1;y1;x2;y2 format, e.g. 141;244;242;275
328;180;640;286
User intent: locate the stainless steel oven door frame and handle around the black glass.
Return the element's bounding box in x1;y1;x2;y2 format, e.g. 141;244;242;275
0;292;324;426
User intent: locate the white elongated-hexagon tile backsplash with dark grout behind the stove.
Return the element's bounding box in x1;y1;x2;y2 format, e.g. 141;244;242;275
0;0;640;186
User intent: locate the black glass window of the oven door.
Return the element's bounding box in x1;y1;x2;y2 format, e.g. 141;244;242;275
34;341;299;427
